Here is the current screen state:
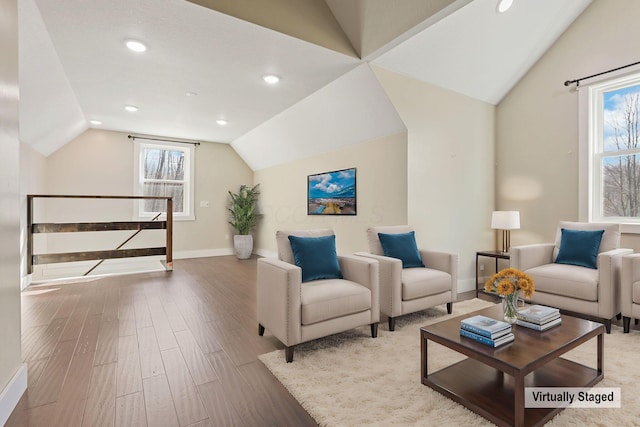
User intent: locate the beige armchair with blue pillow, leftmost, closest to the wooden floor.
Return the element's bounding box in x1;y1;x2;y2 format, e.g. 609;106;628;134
257;229;380;362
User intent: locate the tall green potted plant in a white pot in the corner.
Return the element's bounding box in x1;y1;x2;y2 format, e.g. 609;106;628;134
228;184;260;259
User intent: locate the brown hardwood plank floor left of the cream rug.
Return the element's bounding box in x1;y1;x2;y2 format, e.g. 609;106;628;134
6;257;317;427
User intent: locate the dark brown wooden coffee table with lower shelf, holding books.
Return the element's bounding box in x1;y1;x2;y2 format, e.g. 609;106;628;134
420;305;605;427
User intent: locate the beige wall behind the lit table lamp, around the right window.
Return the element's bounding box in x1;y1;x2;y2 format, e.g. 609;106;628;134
496;0;640;250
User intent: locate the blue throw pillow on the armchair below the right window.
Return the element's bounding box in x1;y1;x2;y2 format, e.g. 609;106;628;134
556;228;604;269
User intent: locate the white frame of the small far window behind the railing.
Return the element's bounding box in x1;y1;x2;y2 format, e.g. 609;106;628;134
133;140;196;221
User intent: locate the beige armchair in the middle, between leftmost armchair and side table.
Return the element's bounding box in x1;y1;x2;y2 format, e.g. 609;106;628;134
356;225;458;331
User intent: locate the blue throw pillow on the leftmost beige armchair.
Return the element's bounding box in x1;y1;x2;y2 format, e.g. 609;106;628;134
289;235;342;282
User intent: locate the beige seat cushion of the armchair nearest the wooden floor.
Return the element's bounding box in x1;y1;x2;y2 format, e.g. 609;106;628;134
300;279;371;325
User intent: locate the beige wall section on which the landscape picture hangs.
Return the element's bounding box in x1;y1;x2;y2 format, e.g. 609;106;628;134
254;133;407;256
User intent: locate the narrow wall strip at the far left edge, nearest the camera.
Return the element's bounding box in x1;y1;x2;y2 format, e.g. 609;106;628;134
0;0;26;424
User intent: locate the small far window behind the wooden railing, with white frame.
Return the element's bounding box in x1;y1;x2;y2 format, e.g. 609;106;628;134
134;141;195;219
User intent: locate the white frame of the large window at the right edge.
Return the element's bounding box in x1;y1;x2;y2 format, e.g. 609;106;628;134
578;67;640;233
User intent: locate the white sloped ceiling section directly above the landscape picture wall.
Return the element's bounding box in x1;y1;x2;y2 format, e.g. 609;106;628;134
231;64;406;170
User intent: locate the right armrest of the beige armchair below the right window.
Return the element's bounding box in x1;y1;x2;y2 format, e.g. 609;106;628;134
598;248;633;319
